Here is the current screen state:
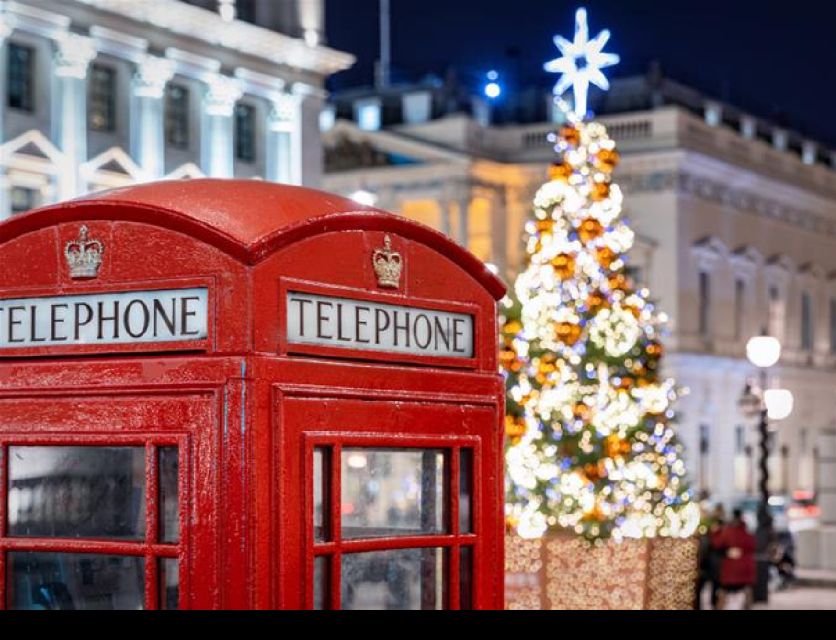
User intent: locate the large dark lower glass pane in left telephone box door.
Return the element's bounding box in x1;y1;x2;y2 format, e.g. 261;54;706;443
6;552;145;610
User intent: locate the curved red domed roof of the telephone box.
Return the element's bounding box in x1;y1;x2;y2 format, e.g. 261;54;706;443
0;178;506;299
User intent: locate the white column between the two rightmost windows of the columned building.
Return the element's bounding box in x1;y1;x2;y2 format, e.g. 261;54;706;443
200;75;244;178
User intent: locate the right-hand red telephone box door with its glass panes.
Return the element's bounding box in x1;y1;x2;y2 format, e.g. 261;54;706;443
279;397;502;609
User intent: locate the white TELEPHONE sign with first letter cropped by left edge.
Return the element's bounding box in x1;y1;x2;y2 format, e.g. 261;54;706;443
0;288;209;349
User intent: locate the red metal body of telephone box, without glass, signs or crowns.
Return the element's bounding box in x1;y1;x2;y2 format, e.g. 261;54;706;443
0;180;504;609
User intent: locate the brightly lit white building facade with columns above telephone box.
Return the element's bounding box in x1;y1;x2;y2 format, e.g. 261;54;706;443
0;0;354;220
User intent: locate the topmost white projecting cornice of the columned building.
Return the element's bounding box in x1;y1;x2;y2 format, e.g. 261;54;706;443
74;0;356;75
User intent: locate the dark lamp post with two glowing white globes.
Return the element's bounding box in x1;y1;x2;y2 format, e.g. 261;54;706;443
740;335;793;602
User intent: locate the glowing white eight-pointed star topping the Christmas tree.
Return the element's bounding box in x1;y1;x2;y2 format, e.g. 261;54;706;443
544;9;619;118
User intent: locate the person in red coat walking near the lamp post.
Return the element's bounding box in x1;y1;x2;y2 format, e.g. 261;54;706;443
711;509;757;609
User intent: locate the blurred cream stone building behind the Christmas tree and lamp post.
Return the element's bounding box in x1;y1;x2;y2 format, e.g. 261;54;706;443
324;70;836;564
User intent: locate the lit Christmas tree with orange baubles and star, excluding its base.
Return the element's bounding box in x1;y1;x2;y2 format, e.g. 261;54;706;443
501;10;699;540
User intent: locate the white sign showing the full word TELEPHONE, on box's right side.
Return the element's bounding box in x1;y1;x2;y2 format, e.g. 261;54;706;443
286;291;474;358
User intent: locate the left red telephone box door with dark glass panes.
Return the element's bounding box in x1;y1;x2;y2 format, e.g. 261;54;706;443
0;389;218;610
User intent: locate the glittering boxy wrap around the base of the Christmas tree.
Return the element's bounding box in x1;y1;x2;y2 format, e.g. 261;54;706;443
505;535;699;610
